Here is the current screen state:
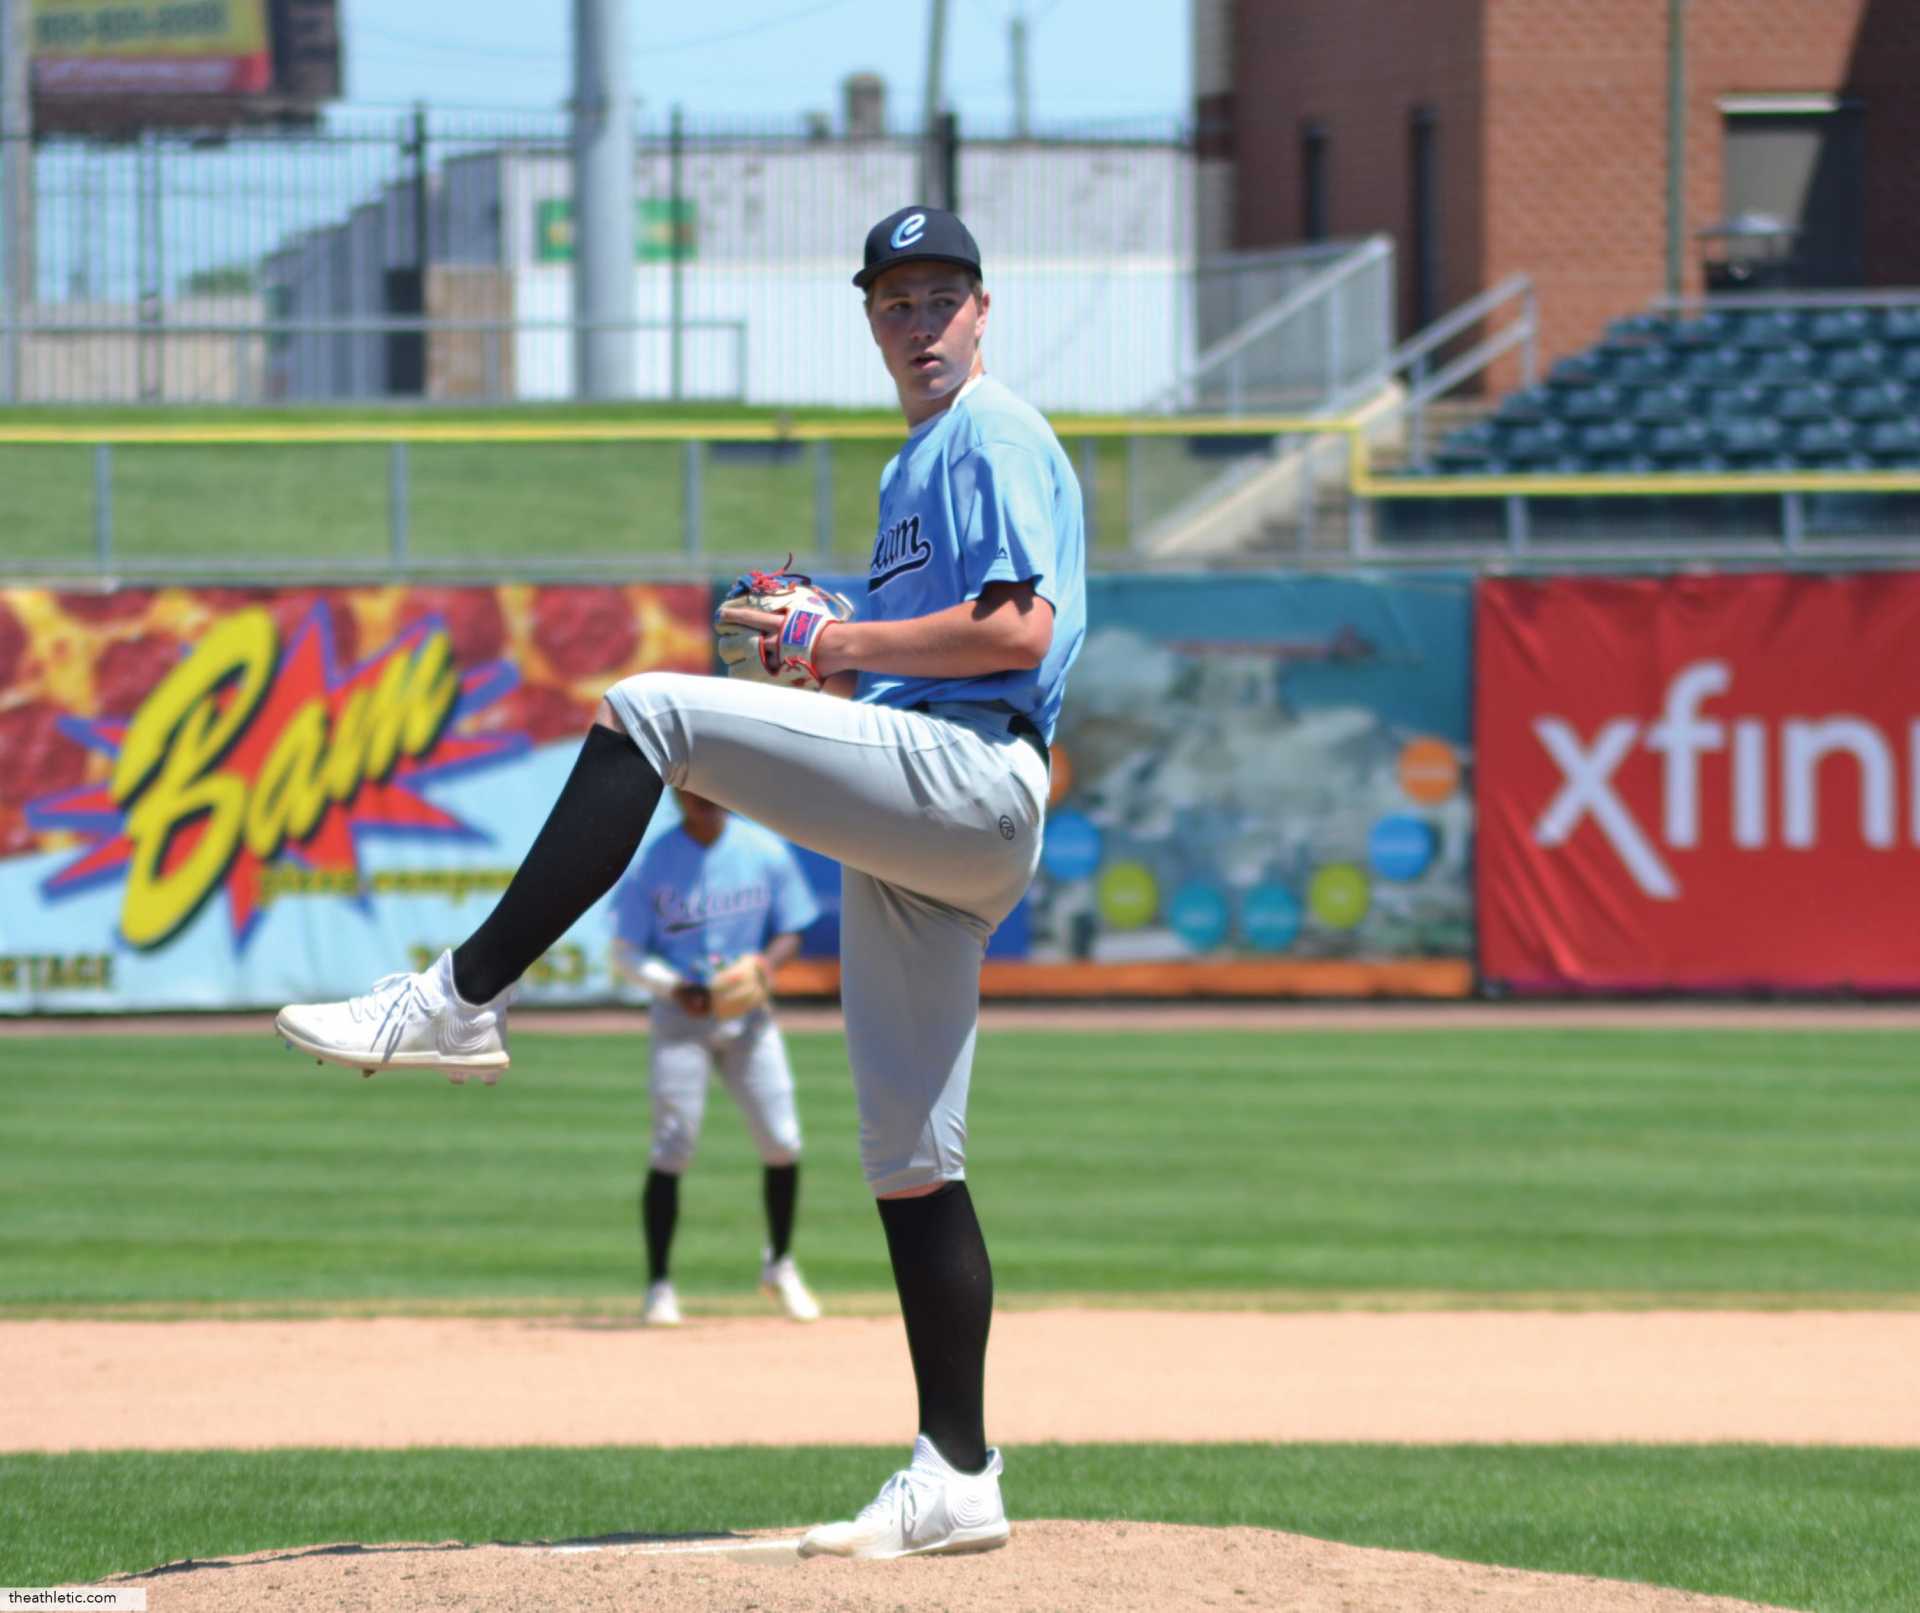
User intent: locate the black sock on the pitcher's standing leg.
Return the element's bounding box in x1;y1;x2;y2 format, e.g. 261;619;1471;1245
879;1181;993;1473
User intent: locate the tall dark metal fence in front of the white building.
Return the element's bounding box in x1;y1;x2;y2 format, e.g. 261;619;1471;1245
0;108;1313;411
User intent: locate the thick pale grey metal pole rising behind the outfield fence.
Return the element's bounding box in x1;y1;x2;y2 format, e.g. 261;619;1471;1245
572;0;634;399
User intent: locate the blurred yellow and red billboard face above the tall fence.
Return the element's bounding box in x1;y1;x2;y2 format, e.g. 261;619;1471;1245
33;0;273;96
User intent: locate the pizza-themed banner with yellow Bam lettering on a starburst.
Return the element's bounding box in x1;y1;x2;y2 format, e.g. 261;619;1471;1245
0;584;710;1012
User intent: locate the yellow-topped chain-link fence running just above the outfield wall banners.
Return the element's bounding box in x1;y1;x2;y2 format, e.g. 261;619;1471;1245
0;415;1920;586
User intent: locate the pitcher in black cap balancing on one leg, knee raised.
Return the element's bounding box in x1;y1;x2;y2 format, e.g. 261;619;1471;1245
278;207;1085;1557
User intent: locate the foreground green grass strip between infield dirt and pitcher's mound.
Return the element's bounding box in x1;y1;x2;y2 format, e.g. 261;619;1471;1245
0;1444;1920;1613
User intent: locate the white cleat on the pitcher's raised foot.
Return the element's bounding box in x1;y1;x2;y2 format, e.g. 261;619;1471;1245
273;952;513;1087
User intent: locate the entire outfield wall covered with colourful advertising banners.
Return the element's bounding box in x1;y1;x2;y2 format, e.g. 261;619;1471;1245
0;574;1920;1014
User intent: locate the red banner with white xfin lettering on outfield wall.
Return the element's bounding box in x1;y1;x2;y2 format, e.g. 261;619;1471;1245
1475;574;1920;991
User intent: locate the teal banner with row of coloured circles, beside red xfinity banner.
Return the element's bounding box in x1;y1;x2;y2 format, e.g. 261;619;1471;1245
1027;574;1473;989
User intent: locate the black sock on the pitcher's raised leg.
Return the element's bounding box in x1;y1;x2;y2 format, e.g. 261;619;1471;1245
453;722;664;1004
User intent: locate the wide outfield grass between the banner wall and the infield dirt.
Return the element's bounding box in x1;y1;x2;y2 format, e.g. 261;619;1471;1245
0;1022;1920;1313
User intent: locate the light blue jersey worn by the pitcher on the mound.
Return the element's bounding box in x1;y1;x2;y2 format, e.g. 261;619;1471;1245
854;376;1087;741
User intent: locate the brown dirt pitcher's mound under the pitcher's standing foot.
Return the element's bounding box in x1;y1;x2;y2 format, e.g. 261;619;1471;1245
111;1523;1781;1613
